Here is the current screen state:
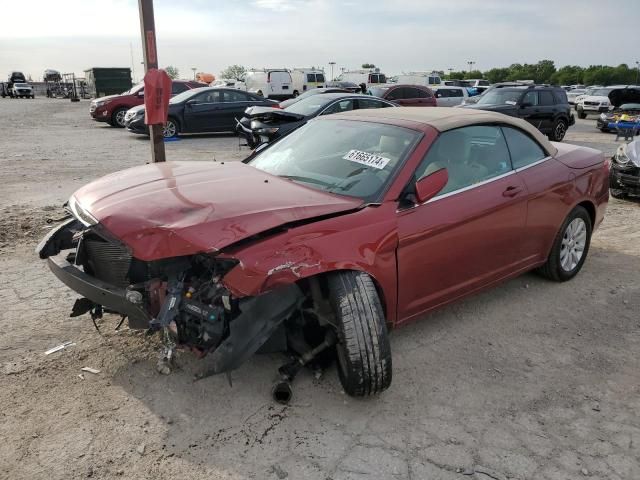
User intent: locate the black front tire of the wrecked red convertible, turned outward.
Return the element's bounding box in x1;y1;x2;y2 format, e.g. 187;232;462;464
329;271;391;397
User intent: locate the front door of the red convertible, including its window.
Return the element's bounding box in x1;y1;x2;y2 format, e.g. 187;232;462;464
397;126;527;322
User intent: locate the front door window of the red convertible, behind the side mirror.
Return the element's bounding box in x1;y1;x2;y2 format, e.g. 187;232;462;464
415;125;511;195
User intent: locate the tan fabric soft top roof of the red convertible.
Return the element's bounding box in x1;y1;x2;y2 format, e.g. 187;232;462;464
332;107;558;155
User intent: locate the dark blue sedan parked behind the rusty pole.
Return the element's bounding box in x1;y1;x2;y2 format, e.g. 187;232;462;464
125;87;276;138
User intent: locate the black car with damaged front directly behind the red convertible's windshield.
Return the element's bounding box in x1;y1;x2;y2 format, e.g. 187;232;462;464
238;93;397;148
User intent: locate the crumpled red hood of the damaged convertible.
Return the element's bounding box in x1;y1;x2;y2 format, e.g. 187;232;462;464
74;162;363;261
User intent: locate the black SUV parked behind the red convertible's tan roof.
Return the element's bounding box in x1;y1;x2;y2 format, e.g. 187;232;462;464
464;85;575;142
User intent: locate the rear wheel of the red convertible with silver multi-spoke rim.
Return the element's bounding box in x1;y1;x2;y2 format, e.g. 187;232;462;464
538;206;592;282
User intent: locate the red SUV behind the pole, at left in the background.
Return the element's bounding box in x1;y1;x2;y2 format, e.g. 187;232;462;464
89;80;207;128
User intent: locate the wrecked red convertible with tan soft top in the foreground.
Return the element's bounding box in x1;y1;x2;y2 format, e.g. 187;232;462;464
38;107;609;400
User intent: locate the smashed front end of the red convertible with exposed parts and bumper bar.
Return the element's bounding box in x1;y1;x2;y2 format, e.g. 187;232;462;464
37;197;304;386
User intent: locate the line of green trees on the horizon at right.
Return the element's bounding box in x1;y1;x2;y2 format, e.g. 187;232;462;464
440;60;639;85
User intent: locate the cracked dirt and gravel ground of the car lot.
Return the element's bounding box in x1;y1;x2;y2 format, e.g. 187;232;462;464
0;99;640;480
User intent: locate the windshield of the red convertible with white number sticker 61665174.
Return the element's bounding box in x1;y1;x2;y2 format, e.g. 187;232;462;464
249;119;422;201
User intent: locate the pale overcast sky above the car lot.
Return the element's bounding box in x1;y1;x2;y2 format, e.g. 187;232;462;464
0;0;640;80
